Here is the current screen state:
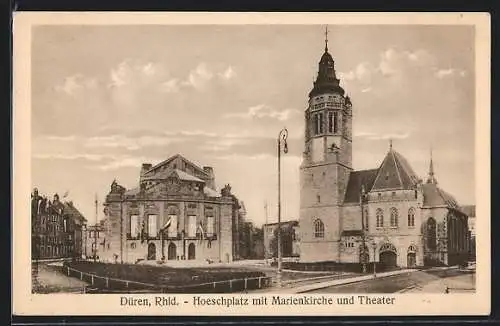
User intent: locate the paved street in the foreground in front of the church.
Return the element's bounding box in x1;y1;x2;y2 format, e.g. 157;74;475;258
302;269;475;293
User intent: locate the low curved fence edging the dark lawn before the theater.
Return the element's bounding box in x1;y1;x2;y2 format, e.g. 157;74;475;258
63;266;272;293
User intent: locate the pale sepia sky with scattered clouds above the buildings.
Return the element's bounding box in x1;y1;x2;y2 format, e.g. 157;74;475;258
32;25;475;224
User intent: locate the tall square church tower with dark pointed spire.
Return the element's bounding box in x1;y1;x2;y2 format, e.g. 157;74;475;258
300;29;352;261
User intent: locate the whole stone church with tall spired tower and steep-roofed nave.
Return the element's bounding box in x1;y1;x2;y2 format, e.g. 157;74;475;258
299;30;469;267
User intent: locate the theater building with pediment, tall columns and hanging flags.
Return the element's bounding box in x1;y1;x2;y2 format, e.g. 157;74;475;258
100;155;241;264
